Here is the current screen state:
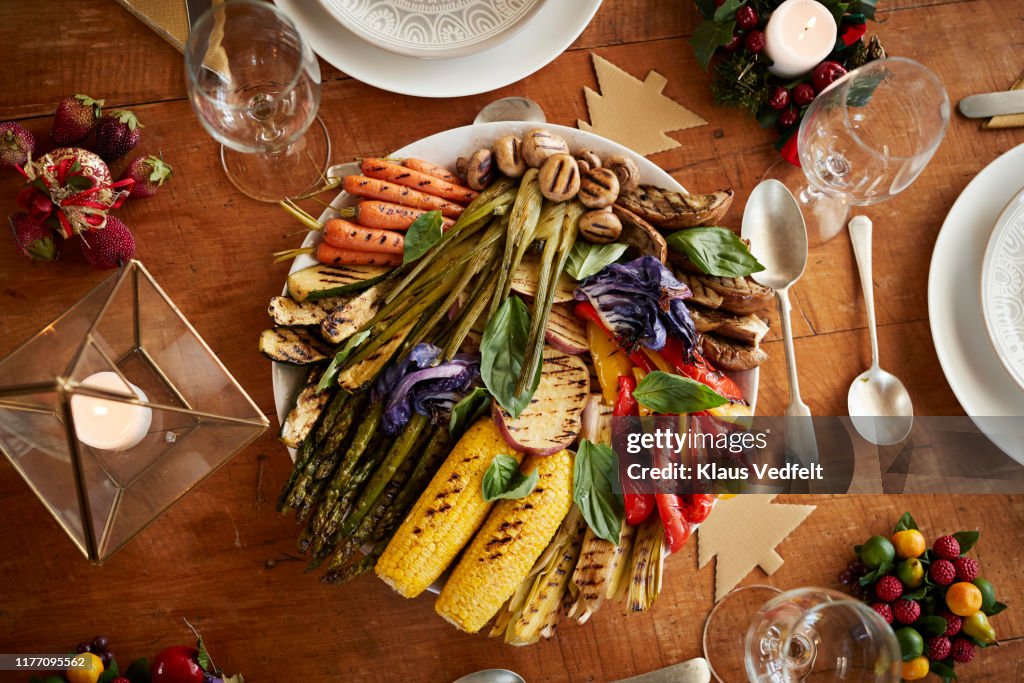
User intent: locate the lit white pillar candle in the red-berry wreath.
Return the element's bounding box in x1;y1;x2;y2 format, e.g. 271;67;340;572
765;0;839;78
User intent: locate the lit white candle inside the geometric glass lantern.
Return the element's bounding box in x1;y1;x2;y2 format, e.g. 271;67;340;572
71;372;153;451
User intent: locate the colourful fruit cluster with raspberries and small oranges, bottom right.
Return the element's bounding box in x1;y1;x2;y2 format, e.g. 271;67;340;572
839;512;1007;681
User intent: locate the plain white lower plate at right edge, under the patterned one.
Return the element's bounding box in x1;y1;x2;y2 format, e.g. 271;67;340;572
928;144;1024;463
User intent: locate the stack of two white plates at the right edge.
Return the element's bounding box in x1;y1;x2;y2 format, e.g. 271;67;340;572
928;144;1024;463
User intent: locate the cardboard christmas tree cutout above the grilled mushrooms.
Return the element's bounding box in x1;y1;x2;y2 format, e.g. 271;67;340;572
577;54;708;156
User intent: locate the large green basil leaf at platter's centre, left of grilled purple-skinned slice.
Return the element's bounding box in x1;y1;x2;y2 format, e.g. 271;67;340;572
480;295;541;418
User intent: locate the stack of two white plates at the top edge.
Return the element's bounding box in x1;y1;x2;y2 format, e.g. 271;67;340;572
274;0;601;97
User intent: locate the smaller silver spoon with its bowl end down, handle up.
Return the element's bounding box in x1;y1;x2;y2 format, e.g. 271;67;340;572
847;216;913;445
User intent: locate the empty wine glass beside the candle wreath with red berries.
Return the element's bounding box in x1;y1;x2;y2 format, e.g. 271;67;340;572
765;57;949;245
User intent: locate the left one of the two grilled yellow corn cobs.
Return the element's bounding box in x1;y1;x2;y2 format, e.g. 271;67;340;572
375;418;520;599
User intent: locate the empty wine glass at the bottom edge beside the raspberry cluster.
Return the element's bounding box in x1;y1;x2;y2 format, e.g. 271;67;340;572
703;586;902;683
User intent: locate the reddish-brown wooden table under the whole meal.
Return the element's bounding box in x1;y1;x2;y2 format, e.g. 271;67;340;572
0;0;1024;682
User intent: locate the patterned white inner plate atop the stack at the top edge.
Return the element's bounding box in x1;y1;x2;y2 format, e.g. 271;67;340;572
321;0;548;59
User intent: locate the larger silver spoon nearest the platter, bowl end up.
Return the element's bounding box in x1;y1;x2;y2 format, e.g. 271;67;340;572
742;180;818;465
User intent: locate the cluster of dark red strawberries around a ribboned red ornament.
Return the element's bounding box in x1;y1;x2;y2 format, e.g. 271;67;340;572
0;94;171;268
